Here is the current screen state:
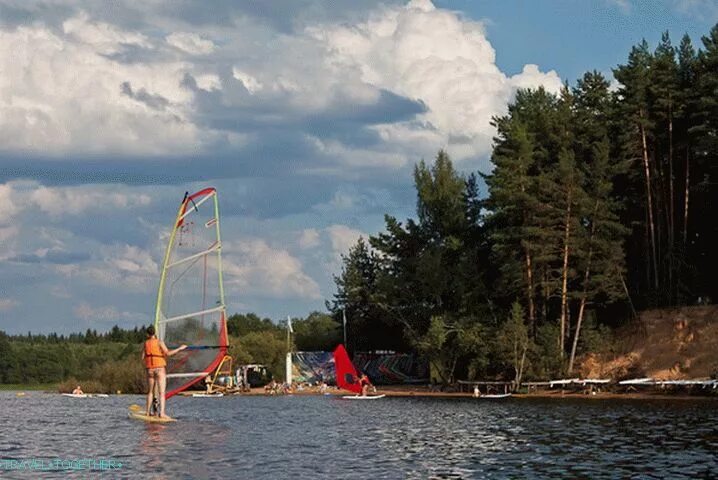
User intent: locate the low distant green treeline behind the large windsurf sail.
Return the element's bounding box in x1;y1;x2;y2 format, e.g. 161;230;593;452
0;312;341;393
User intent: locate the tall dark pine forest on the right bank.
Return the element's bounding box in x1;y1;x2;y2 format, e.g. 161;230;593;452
328;25;718;382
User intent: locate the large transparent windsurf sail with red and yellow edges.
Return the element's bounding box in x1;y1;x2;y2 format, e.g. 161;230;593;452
155;188;228;398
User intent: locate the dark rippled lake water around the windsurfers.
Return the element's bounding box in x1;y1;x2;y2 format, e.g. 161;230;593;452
0;392;718;479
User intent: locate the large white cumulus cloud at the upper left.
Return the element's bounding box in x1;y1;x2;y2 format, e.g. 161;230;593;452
0;15;203;157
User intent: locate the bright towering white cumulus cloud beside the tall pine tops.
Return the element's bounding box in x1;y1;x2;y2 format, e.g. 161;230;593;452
310;0;561;158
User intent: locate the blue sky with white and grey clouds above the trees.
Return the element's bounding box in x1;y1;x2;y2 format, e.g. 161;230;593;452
0;0;718;333
